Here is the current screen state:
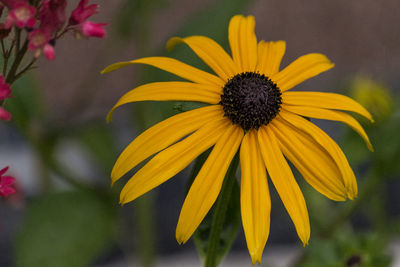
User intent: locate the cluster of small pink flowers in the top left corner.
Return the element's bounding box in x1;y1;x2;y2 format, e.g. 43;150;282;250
0;0;106;60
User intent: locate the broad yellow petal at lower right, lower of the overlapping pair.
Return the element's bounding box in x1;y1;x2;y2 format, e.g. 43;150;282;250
269;117;347;201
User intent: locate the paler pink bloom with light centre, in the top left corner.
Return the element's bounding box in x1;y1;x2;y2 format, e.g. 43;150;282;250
6;1;36;28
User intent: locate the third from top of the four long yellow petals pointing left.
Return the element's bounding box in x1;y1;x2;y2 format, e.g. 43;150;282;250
111;105;223;183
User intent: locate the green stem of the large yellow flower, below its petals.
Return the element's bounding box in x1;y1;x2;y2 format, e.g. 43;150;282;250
204;153;239;267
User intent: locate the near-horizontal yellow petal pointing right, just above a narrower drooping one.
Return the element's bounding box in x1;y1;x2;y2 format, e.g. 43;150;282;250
282;91;374;122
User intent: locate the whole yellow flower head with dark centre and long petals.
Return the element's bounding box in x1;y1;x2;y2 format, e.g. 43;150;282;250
103;15;372;264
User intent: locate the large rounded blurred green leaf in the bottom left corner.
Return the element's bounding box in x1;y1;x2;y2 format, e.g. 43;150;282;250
16;191;115;267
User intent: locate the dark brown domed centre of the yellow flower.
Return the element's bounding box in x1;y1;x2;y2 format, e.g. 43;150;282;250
220;72;282;131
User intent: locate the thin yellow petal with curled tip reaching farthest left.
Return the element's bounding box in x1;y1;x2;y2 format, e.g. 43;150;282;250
101;57;225;88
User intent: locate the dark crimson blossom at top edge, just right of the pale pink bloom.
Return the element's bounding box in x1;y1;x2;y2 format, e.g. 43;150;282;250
39;0;67;35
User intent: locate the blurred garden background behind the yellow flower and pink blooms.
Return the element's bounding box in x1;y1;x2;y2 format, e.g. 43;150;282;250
0;0;400;267
